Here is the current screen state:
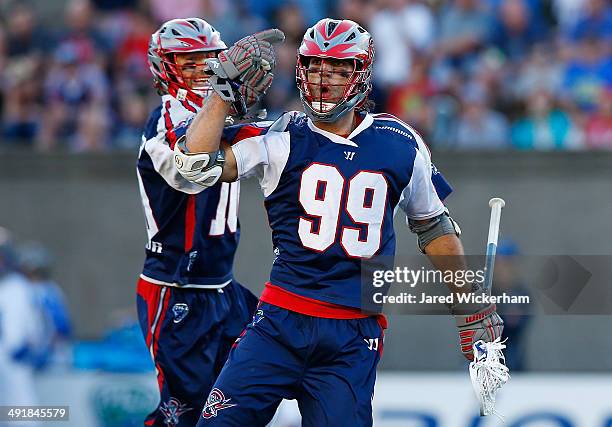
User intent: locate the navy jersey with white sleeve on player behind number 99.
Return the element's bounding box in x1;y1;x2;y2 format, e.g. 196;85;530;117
137;95;252;288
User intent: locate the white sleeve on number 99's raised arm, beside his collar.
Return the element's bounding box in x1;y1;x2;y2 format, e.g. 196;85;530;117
232;113;292;197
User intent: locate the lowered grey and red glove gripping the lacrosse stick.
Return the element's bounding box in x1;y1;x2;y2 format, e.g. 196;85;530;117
450;285;504;360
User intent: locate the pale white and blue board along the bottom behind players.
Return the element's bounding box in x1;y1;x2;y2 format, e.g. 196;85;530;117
32;371;612;427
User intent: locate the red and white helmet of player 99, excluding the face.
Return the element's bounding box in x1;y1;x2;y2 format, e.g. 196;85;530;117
295;18;374;122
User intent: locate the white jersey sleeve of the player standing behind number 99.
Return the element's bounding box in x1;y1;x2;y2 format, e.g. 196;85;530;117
140;95;204;194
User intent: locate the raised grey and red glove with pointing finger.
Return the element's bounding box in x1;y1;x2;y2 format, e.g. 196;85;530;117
206;29;285;115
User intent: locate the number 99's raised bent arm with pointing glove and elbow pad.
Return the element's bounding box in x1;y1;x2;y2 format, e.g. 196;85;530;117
175;29;285;187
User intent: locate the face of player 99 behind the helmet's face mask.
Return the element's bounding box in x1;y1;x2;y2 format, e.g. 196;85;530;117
308;58;355;110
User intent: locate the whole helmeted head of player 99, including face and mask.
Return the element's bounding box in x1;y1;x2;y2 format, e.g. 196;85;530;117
296;19;374;122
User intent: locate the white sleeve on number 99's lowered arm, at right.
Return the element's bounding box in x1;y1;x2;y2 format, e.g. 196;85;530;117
399;131;446;220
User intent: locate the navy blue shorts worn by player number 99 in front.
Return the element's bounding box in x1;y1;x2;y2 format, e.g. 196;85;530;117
197;302;384;427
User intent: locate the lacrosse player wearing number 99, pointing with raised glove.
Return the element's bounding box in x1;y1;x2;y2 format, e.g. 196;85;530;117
175;19;503;427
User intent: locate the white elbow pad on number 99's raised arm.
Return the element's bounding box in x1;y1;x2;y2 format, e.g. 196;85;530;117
174;135;225;188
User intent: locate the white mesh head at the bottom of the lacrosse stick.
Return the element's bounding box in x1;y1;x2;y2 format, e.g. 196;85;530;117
470;337;510;421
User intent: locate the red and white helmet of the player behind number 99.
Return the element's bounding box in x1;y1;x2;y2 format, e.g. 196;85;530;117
147;18;227;103
